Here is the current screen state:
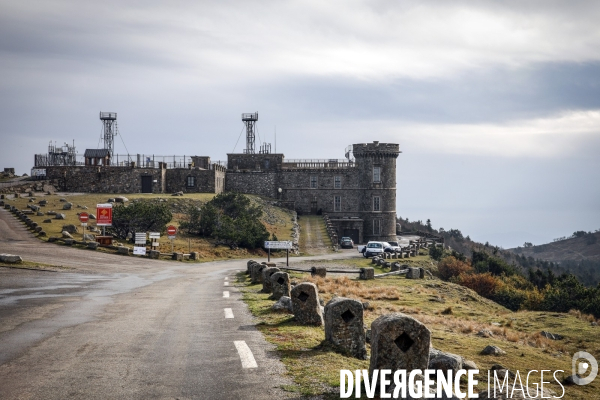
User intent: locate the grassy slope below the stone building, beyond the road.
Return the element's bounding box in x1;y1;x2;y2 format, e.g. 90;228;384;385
4;193;293;261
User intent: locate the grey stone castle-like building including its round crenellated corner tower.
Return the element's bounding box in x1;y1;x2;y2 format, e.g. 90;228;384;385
225;142;400;243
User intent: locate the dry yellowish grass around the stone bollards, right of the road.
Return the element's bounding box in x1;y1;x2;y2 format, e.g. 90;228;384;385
238;256;600;399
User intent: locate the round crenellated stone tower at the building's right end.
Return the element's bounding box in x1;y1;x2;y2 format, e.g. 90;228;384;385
352;142;400;242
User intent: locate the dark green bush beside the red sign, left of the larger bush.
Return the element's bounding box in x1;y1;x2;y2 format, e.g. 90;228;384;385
109;200;173;239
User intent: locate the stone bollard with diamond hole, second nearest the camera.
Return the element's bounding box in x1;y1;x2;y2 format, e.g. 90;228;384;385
325;297;367;360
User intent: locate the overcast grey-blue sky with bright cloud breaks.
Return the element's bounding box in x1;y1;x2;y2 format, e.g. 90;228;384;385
0;0;600;247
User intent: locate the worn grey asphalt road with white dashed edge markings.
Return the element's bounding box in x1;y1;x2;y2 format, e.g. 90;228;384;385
0;209;358;399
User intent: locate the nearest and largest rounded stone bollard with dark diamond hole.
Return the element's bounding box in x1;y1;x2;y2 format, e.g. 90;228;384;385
369;313;431;373
